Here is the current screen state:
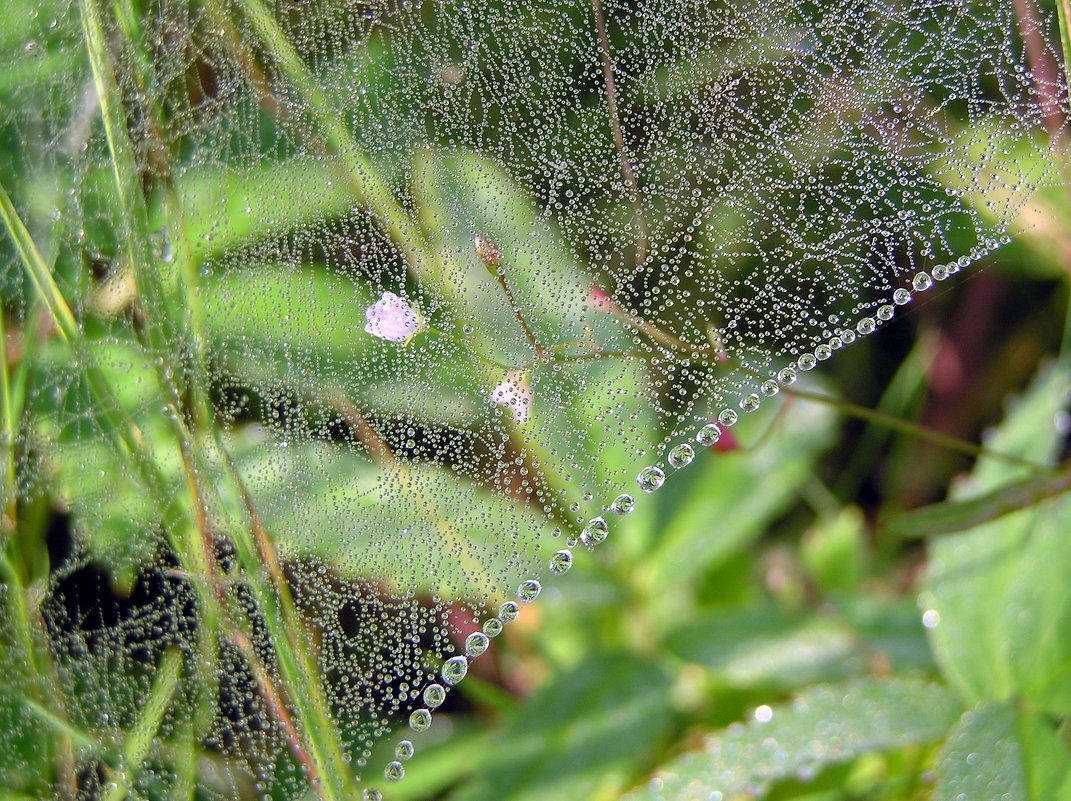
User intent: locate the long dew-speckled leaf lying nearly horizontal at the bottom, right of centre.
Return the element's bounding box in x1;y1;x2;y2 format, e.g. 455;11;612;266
628;679;960;801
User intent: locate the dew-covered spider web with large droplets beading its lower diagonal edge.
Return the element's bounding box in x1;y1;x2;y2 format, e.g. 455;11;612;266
0;0;1067;801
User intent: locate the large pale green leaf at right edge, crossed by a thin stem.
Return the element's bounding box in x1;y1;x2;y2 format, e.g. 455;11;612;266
920;359;1071;714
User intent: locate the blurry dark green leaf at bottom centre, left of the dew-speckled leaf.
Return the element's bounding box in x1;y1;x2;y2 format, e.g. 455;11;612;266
451;653;670;801
